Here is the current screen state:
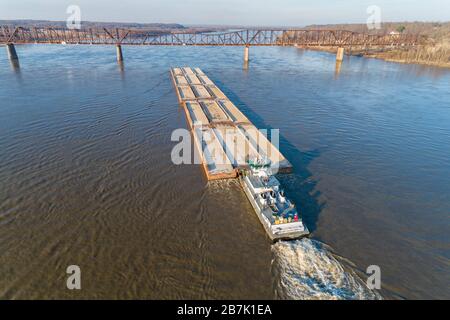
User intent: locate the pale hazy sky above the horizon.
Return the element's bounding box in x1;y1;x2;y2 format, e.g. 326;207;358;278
0;0;450;26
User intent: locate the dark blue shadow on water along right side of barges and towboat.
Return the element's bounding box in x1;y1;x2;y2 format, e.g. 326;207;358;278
215;80;325;232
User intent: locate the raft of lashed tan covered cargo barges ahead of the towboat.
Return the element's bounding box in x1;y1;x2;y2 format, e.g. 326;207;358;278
170;68;292;180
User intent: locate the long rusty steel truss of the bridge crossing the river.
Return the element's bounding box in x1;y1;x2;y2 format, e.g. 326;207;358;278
0;26;421;46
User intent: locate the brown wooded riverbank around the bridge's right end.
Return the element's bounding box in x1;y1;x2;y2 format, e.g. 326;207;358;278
299;22;450;68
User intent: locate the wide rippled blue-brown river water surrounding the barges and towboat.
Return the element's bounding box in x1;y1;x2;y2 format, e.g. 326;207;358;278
0;45;450;299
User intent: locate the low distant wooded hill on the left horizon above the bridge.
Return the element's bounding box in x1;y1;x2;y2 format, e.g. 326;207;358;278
0;20;186;31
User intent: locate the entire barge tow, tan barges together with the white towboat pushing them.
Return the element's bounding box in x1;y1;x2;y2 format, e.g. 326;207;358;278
170;67;309;241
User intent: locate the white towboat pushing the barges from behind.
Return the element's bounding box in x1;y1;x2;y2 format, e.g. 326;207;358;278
239;158;309;241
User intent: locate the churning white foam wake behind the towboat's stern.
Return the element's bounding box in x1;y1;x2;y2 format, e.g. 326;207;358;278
272;238;382;300
